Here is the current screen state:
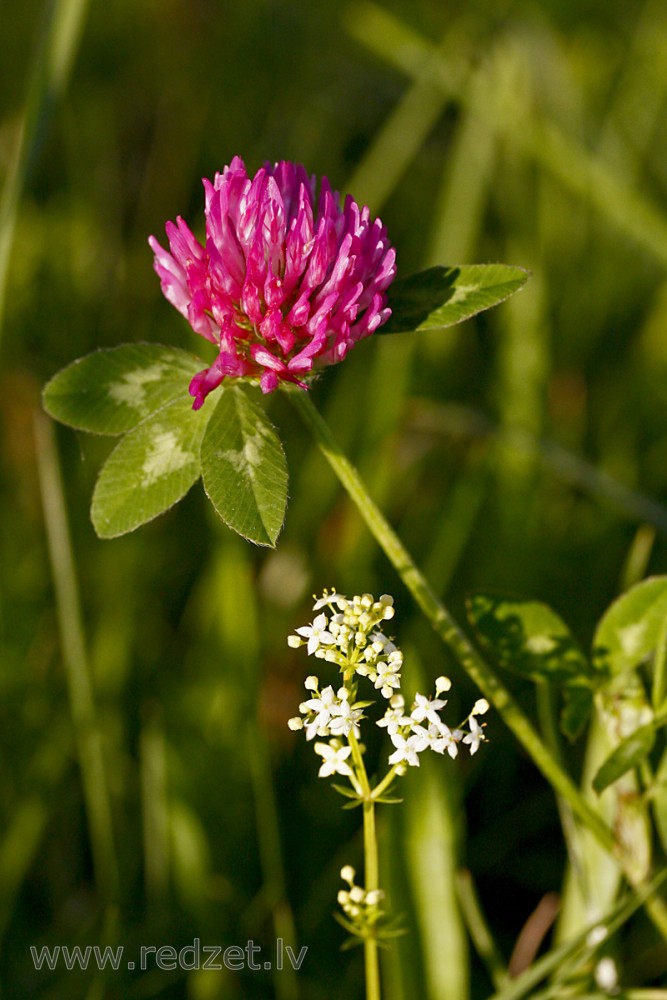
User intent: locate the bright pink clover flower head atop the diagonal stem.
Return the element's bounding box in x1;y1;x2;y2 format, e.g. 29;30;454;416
149;156;396;409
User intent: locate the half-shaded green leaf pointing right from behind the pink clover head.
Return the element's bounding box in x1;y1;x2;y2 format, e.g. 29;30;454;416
378;264;530;333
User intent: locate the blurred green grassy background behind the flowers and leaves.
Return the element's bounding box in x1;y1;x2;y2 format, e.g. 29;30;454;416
0;0;667;1000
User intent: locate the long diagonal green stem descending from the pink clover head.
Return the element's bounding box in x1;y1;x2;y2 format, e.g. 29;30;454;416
289;391;615;853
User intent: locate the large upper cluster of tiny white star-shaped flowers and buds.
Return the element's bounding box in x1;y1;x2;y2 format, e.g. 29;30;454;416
287;590;489;777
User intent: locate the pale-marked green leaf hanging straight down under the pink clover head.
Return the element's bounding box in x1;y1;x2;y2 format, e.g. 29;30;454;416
201;386;287;547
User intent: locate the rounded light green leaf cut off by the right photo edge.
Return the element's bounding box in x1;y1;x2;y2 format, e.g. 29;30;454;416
593;576;667;675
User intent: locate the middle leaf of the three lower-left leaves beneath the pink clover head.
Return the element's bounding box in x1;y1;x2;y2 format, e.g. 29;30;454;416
91;398;211;538
